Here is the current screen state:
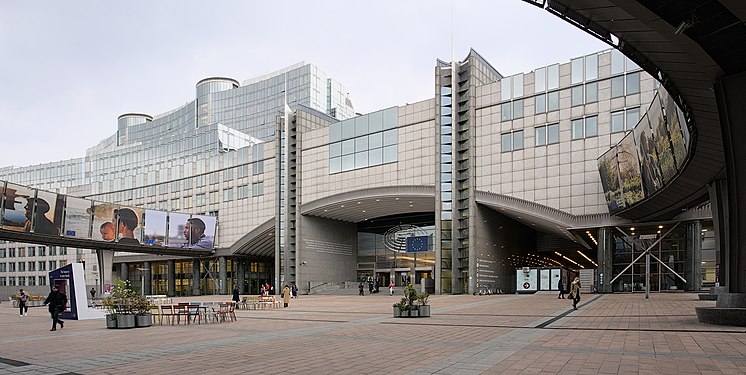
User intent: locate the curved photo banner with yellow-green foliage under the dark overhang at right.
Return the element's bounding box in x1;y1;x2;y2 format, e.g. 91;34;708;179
598;87;689;214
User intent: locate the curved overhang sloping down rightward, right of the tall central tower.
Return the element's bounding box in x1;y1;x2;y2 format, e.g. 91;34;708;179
475;191;628;245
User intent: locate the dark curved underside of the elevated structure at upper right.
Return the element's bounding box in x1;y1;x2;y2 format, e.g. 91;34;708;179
526;0;746;221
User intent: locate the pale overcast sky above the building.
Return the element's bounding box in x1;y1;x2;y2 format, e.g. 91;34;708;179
0;0;609;166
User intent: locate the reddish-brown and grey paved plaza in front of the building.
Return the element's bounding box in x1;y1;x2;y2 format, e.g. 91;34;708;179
0;293;746;375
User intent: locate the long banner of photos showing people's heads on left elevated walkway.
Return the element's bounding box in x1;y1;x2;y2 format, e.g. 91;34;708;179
0;181;217;250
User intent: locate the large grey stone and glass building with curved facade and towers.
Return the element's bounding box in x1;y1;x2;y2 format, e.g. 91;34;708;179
0;50;719;295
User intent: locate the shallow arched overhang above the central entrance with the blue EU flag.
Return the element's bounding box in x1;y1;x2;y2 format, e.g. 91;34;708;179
300;186;435;223
